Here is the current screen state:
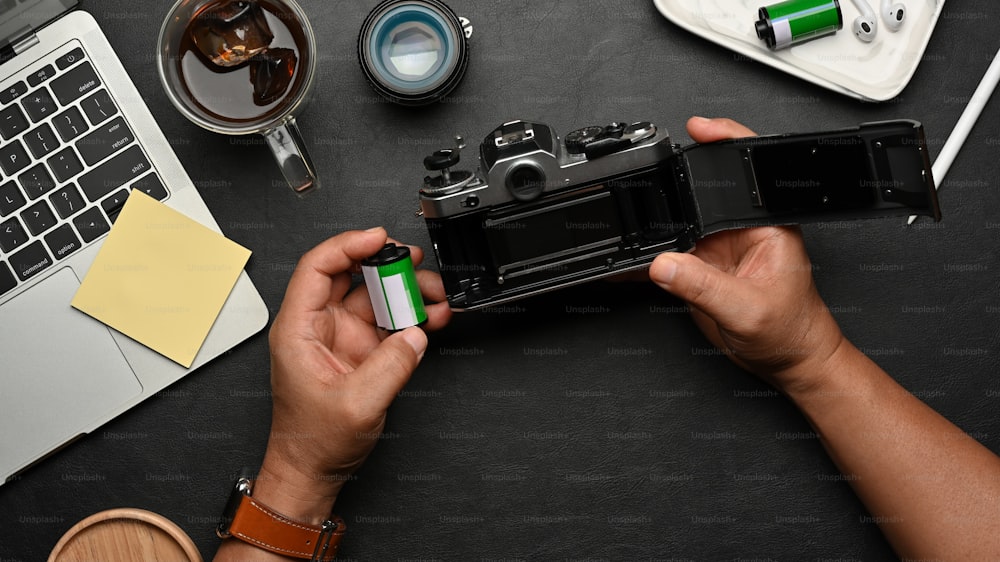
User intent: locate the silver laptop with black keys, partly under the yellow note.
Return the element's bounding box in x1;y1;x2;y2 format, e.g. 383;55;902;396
0;0;268;484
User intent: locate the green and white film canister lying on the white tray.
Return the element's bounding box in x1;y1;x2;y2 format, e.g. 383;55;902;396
755;0;844;51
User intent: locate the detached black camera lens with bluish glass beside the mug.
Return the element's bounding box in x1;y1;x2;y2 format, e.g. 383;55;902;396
358;0;469;105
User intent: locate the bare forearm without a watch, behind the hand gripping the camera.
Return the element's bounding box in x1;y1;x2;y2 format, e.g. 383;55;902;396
789;340;1000;560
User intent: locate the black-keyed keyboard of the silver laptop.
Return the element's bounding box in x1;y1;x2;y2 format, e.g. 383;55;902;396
0;44;167;296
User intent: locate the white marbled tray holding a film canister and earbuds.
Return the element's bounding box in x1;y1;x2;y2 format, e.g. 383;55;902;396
653;0;944;101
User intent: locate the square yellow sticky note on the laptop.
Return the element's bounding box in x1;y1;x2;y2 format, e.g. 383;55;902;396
72;190;250;367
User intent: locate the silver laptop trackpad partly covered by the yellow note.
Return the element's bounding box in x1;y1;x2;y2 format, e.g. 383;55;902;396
0;268;142;468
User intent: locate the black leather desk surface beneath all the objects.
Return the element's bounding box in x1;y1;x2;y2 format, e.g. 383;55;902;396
0;0;1000;562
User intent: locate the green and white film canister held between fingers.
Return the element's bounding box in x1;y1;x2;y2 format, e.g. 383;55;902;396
361;244;427;331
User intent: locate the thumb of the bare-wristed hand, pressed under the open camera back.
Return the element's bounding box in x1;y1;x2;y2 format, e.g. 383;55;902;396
649;253;753;324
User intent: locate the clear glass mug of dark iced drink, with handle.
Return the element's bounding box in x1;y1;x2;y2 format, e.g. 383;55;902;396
156;0;319;193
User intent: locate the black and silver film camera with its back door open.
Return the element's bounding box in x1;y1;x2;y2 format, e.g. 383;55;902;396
420;120;941;310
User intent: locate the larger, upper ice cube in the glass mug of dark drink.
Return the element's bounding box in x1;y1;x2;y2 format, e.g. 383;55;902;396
190;0;274;67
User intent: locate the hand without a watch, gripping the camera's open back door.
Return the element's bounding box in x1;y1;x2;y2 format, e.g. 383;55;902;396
649;117;844;393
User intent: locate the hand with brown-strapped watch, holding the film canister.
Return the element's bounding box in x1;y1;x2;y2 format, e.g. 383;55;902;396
254;228;451;522
